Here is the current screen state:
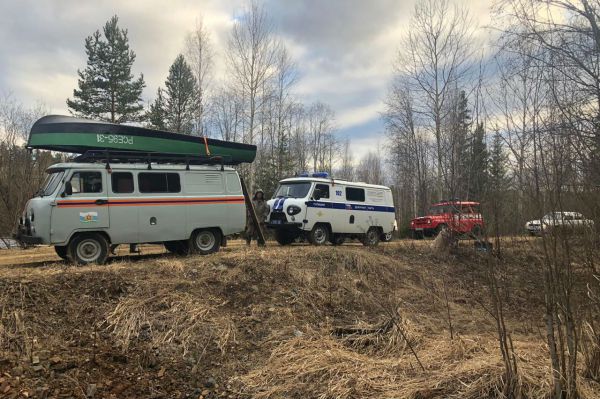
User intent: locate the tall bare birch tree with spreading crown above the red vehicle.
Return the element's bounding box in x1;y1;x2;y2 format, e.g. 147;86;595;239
396;0;474;197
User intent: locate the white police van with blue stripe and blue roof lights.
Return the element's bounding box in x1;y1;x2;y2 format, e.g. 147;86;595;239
267;173;395;246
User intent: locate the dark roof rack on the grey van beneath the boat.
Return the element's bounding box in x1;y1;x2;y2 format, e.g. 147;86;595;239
74;149;232;170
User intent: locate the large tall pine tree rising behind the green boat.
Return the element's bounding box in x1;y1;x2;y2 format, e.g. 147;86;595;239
67;15;145;123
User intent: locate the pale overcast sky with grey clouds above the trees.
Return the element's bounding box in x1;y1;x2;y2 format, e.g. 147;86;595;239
0;0;490;157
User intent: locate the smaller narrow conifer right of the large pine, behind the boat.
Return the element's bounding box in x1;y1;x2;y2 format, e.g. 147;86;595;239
165;54;197;134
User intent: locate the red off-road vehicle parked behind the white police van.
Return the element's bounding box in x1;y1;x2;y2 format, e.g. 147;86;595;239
410;201;485;239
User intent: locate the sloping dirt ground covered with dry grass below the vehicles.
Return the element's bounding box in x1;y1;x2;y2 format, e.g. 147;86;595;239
0;238;600;399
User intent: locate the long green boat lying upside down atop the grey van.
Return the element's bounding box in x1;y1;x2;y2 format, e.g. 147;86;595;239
27;115;256;165
